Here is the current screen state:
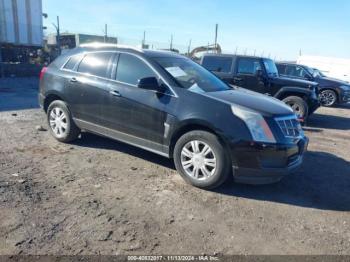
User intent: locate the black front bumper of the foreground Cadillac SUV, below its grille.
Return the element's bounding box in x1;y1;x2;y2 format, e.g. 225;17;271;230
231;137;309;184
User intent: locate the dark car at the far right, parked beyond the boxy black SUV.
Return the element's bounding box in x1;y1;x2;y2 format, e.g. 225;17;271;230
277;63;350;106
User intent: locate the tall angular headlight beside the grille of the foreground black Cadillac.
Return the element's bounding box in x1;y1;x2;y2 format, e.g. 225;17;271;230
231;106;276;143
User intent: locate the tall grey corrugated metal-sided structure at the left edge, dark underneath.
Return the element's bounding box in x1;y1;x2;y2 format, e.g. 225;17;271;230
0;0;43;76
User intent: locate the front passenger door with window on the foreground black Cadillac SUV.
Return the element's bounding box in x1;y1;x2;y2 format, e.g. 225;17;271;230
103;53;169;144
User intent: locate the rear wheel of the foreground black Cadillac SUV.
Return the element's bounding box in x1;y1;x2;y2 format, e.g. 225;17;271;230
47;100;80;143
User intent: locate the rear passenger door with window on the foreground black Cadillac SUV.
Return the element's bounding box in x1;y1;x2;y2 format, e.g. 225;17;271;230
63;52;115;124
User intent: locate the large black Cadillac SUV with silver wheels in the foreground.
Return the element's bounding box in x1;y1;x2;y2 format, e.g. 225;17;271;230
39;44;308;188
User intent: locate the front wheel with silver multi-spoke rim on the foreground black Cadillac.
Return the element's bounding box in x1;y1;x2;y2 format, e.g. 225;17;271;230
174;131;232;189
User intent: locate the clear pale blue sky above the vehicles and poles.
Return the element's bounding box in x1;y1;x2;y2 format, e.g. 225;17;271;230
43;0;350;60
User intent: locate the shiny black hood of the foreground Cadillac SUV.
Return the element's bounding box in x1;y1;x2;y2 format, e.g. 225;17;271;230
205;88;293;116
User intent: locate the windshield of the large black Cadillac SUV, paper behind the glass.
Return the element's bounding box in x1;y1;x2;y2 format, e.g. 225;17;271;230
153;57;231;93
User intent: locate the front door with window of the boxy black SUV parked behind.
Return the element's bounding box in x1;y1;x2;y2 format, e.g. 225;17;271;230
233;57;266;94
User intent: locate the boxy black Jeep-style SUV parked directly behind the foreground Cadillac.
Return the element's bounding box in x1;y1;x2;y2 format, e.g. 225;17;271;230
200;54;320;121
